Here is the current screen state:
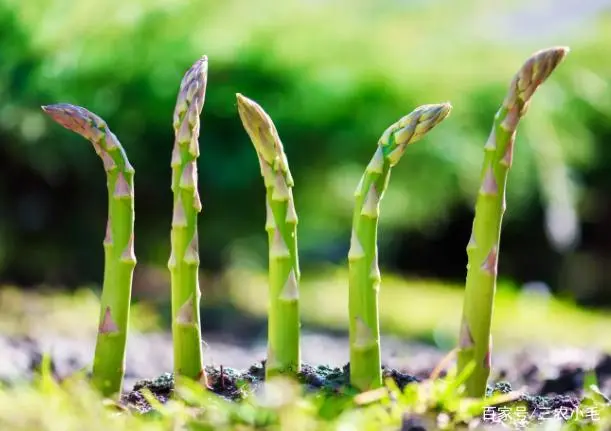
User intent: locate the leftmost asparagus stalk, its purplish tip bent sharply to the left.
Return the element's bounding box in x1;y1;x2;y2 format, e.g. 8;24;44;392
42;104;136;396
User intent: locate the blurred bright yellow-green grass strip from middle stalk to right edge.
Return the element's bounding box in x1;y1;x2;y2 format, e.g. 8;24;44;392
226;268;611;351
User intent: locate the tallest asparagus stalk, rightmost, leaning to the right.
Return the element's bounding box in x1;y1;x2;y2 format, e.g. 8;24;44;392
458;47;568;397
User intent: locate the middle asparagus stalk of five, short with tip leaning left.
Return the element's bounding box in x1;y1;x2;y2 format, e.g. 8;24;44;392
237;94;301;378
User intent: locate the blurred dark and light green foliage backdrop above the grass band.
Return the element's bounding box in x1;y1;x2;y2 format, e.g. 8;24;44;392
0;0;611;330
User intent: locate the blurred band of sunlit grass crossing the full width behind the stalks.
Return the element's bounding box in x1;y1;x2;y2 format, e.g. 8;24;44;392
0;266;611;352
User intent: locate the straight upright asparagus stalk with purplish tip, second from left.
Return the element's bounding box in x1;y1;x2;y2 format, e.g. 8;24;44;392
168;56;208;384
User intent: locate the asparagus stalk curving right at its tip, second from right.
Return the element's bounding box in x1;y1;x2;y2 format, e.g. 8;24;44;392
348;103;452;391
